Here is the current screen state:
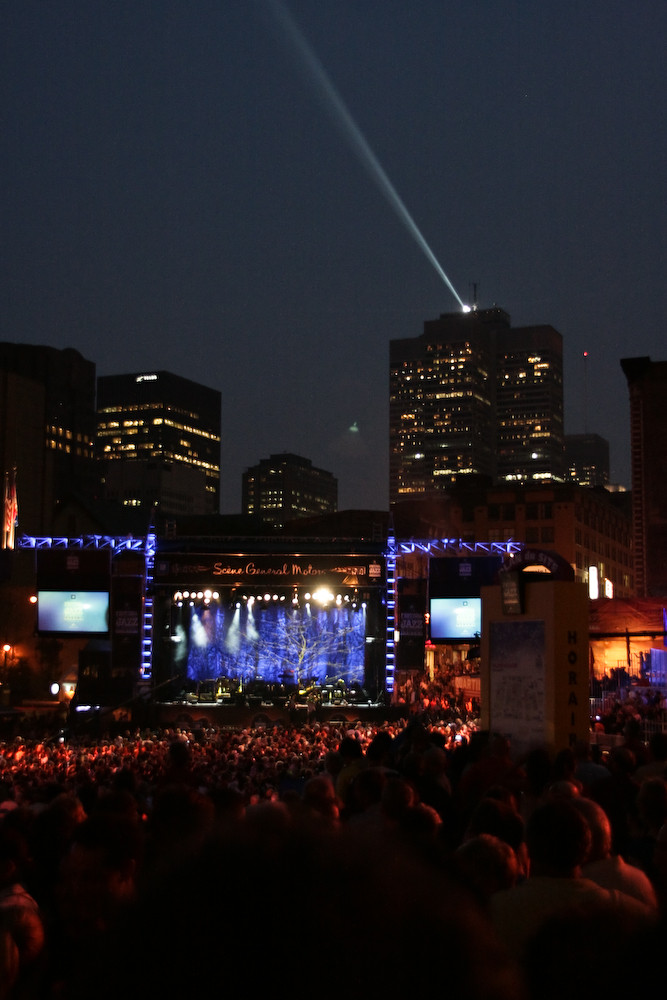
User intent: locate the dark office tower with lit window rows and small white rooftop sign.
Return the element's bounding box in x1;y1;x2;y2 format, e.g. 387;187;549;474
97;371;221;514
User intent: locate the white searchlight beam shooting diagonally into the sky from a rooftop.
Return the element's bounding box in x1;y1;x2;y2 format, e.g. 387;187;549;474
267;0;470;312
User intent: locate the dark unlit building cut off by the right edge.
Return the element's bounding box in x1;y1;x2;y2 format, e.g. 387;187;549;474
621;357;667;597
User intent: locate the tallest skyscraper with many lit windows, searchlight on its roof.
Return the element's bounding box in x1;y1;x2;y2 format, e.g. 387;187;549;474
389;307;563;503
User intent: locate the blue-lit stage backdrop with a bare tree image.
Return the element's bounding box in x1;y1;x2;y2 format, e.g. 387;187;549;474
177;605;366;684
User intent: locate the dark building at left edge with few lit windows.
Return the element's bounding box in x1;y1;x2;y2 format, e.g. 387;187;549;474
0;342;96;535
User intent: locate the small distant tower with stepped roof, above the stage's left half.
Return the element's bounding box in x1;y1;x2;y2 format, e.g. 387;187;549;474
242;452;338;528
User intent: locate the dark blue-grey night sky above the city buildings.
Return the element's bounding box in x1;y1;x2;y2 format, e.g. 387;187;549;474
0;0;667;512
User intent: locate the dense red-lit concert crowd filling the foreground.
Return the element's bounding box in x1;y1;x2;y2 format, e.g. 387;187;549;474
0;715;667;1000
